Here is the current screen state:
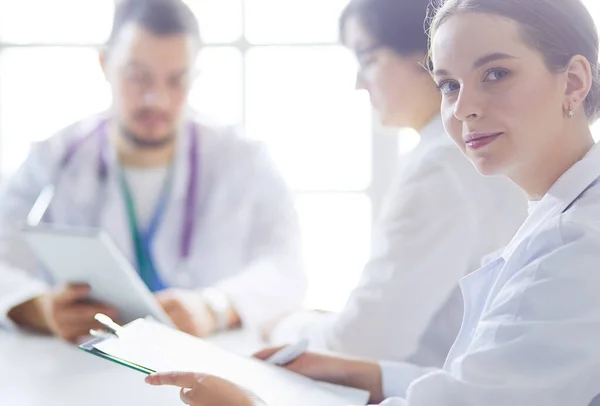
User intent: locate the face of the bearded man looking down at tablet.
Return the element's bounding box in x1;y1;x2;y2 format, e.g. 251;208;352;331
102;23;199;147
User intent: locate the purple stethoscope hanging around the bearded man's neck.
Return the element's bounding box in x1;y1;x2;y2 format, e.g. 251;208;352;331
27;120;200;259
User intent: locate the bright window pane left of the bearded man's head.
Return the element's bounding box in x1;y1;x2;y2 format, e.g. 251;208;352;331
0;47;110;170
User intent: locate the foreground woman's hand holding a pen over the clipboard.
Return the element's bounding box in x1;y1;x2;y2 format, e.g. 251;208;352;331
254;347;383;403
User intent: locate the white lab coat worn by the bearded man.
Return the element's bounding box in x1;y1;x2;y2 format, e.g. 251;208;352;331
0;111;306;326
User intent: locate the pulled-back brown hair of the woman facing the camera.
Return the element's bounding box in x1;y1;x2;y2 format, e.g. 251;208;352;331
431;0;600;121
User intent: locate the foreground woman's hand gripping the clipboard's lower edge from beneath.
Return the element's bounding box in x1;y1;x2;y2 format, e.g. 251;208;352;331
146;372;264;406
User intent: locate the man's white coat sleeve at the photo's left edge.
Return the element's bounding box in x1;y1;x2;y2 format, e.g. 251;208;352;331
0;144;51;327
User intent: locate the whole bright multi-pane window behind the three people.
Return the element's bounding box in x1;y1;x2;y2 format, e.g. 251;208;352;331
0;0;382;310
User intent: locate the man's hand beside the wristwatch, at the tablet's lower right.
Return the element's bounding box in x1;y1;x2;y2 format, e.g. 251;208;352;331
156;289;217;337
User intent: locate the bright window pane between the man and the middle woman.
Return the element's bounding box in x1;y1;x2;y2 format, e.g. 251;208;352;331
246;46;371;191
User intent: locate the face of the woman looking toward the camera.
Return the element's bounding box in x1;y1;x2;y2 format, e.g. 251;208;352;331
432;13;567;176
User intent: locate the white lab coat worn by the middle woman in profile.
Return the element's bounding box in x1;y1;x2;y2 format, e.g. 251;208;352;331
273;116;527;368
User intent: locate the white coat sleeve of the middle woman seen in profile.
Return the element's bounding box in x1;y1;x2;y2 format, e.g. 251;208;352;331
276;150;475;378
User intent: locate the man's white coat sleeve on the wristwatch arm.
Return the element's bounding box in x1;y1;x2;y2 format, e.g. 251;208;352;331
216;144;307;327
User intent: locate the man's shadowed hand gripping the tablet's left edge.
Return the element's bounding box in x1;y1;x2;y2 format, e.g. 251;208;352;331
8;285;119;342
